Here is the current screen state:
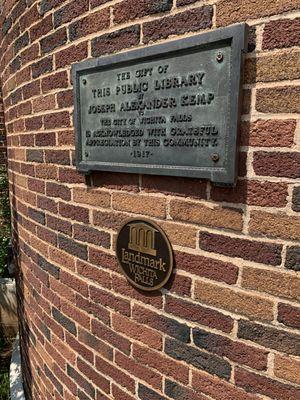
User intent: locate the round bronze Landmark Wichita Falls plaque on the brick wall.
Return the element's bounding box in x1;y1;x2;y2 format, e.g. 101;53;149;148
116;219;173;291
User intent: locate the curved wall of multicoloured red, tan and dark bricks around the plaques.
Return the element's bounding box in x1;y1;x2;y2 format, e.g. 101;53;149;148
1;0;300;400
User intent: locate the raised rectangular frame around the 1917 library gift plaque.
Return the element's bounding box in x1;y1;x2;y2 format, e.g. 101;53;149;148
71;23;248;185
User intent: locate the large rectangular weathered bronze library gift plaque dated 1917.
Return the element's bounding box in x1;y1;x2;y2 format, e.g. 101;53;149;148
72;24;247;184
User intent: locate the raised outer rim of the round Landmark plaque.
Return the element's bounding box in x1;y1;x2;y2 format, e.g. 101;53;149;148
114;217;174;292
